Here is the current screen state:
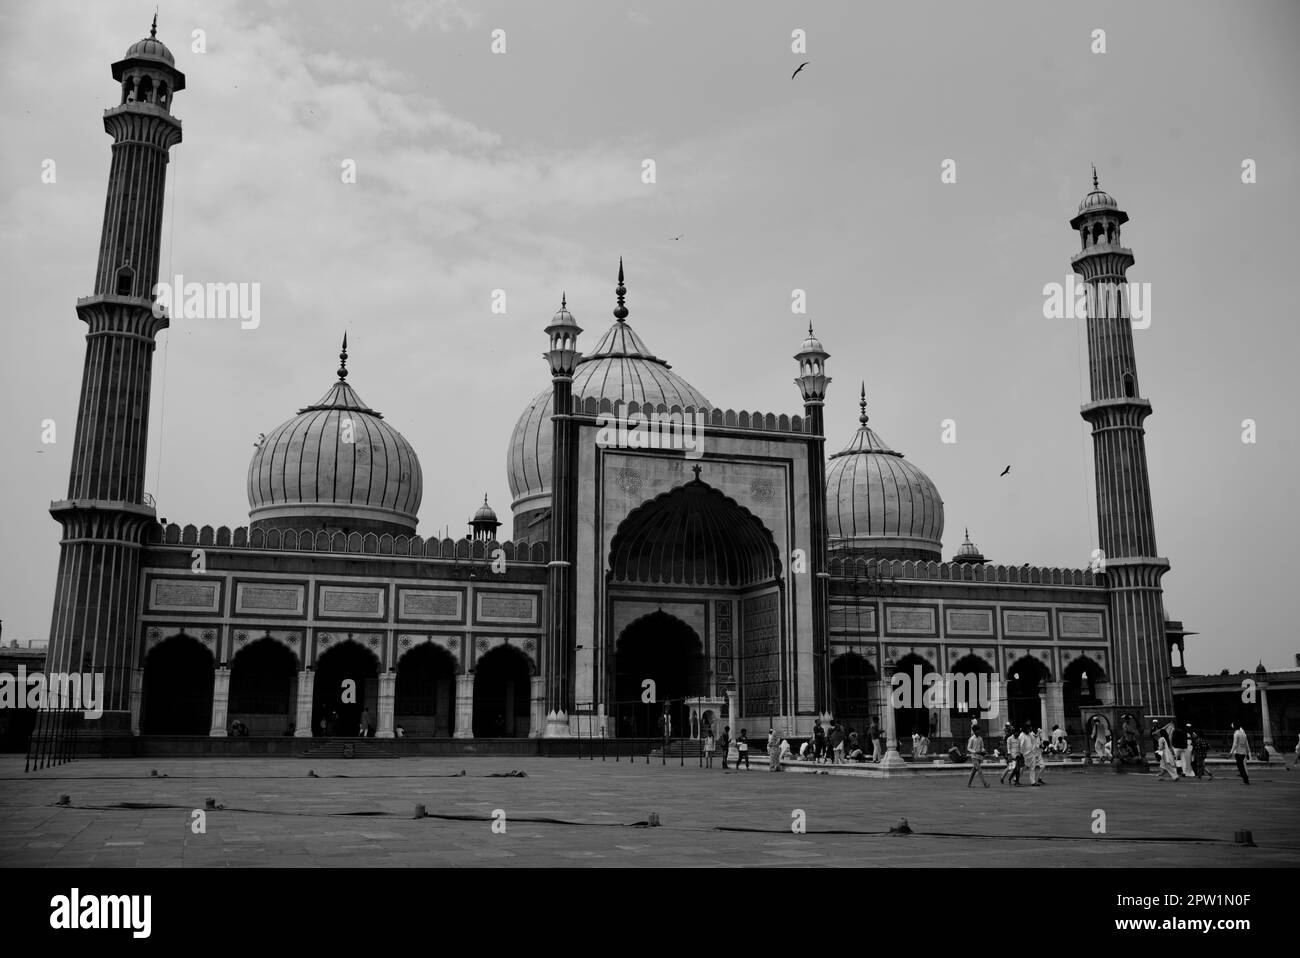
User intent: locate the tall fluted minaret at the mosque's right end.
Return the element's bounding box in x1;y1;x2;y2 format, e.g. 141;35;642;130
1070;168;1174;718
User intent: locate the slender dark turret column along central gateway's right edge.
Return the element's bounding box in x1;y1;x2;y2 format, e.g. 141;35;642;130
788;322;832;714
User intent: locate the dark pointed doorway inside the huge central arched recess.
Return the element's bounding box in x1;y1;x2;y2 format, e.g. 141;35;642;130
614;612;707;738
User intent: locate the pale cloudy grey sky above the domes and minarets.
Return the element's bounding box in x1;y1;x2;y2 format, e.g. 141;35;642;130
0;0;1300;672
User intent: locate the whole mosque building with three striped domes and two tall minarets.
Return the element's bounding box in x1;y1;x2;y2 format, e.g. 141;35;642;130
47;21;1188;742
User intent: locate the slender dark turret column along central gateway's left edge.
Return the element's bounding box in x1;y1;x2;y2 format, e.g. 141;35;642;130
542;283;582;738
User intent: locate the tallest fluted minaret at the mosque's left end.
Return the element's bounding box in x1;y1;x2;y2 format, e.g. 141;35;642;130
46;14;185;734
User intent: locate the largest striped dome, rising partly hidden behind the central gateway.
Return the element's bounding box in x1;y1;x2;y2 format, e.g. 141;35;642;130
506;264;712;522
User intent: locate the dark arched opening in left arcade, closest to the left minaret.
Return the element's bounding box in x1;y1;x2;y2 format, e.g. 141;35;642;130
140;632;213;736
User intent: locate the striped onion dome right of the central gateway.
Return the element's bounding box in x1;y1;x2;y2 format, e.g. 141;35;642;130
826;385;944;562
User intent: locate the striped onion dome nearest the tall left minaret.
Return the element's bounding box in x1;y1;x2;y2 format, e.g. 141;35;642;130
248;335;424;536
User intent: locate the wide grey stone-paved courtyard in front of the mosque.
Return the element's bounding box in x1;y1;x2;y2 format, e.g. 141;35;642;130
0;755;1300;868
